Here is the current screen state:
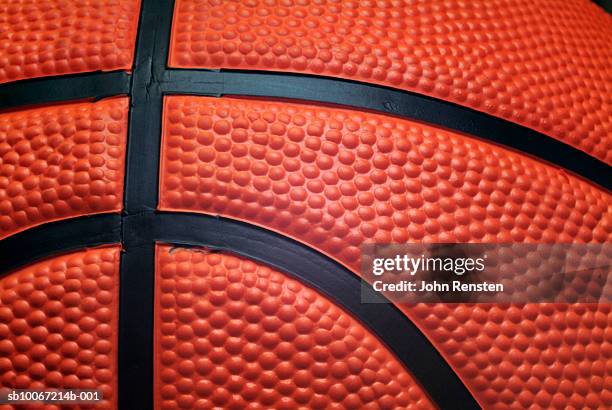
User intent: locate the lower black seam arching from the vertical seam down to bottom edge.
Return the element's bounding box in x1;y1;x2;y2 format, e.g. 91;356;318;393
124;212;480;409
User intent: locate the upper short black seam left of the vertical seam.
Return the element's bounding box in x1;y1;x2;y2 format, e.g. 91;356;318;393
0;71;130;110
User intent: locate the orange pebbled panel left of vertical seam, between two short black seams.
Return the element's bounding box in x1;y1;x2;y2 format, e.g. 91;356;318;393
0;98;129;239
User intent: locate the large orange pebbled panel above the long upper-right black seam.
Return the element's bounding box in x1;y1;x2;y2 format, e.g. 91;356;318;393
169;0;612;164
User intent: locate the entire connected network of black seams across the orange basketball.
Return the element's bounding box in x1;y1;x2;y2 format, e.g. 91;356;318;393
0;0;612;409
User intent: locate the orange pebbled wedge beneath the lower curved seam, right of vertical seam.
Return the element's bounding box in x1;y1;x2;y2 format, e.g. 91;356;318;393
155;246;433;410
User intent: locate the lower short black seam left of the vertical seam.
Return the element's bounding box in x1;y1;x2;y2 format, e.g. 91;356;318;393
0;214;121;274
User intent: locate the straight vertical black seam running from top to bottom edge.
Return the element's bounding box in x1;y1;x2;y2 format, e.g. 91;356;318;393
117;0;174;410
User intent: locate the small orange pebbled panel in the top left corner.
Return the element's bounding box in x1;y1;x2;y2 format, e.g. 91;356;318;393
0;0;140;84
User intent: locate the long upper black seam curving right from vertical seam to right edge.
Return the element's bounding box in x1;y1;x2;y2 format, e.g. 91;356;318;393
161;69;612;191
